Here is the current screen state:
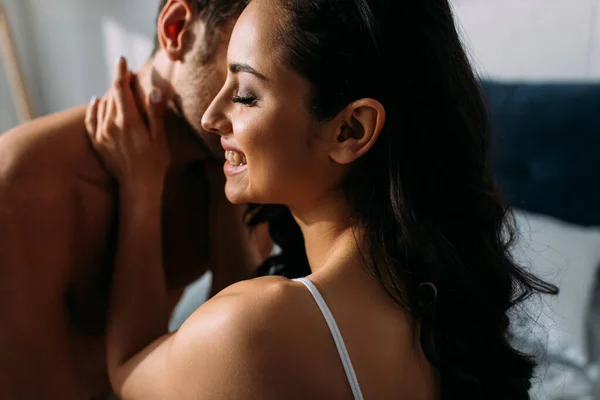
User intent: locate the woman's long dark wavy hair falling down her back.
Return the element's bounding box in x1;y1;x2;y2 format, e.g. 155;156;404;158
247;0;557;400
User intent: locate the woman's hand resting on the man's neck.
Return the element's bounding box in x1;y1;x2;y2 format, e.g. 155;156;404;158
85;58;170;197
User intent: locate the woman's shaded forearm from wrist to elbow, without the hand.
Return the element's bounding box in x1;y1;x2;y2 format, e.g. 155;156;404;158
107;185;170;375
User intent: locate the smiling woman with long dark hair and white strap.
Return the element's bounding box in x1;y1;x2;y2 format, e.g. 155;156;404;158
88;0;556;400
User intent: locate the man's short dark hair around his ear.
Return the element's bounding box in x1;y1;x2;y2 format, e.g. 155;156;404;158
152;0;249;62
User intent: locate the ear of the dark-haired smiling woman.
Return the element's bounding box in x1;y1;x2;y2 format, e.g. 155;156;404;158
329;99;386;164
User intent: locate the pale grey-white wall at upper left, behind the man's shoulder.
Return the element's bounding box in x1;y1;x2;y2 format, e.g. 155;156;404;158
0;0;159;132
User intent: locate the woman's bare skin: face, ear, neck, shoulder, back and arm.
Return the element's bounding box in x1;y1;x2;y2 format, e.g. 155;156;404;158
88;0;439;400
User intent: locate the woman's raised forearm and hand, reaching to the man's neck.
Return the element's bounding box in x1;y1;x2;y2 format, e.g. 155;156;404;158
86;59;170;390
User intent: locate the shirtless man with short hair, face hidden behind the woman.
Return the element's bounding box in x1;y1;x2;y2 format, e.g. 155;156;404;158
0;0;270;400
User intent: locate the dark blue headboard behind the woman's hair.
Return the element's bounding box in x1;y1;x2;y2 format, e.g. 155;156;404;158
482;82;600;225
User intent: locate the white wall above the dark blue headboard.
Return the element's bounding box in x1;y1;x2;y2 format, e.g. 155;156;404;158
453;0;600;81
